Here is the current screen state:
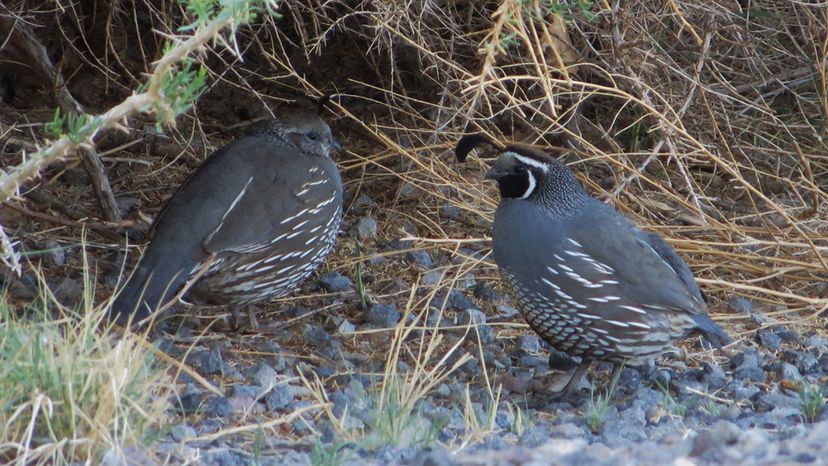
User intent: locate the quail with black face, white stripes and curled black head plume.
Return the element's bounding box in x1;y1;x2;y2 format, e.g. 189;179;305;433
455;135;731;397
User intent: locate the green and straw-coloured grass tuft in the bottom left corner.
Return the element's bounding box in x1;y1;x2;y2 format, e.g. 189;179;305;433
0;249;172;465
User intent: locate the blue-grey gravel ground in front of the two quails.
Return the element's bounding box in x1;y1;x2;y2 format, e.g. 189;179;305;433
87;276;828;466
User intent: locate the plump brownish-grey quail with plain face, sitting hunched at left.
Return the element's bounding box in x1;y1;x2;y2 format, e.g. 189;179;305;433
111;115;342;325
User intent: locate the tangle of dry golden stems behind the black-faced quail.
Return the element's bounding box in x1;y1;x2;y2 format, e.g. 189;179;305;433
254;1;828;330
